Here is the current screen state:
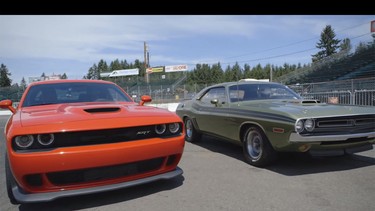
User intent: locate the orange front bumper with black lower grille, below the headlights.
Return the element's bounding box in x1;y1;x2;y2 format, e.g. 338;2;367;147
9;136;185;194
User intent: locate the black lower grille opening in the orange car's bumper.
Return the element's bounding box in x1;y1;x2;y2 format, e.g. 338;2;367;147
47;158;164;185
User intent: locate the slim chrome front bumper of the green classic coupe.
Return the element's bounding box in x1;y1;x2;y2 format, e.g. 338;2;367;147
289;131;375;143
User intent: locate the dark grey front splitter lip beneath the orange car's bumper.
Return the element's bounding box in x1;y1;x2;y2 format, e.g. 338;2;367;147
12;167;183;203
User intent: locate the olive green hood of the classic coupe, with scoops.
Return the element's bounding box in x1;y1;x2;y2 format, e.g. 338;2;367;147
240;100;375;119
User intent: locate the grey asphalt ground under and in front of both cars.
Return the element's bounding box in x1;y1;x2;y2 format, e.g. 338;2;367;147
0;116;375;211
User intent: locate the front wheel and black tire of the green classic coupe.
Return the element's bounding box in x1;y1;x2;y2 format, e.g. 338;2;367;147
242;127;277;167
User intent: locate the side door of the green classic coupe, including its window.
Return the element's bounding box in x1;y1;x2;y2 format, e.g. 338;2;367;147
196;86;232;137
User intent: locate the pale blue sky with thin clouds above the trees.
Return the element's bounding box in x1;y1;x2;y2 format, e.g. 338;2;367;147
0;15;375;83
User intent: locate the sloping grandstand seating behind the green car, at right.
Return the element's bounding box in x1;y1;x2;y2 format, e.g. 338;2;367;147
276;44;375;84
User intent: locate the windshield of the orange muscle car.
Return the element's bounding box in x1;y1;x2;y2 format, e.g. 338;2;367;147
22;82;132;107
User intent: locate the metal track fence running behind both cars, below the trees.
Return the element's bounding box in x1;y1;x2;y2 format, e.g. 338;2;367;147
0;78;375;106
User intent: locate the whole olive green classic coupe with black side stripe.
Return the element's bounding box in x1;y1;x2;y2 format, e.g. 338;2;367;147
176;81;375;167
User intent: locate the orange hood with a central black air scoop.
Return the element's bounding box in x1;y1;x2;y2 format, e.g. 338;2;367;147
15;103;178;130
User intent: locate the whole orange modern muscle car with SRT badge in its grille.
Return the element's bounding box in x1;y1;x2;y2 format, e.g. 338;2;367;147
0;80;185;204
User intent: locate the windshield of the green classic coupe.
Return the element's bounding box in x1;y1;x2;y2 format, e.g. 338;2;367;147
229;83;301;102
